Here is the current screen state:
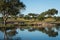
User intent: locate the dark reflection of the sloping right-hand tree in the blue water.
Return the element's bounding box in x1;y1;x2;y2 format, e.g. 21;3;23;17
38;28;58;37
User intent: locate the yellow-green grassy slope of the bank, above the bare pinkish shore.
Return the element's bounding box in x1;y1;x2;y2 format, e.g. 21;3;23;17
0;18;60;27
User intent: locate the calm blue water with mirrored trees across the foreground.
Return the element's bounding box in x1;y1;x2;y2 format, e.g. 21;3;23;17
0;26;60;40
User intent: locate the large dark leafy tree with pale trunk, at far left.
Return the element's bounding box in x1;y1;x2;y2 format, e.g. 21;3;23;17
0;0;25;24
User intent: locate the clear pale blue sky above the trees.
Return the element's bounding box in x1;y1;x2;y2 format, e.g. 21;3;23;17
21;0;60;16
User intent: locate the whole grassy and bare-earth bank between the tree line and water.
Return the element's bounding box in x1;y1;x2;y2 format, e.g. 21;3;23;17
0;18;60;27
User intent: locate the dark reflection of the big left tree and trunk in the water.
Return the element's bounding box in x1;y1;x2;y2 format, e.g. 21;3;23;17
0;28;21;40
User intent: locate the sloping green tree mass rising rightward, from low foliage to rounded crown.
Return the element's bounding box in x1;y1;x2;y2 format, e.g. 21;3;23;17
38;9;58;20
